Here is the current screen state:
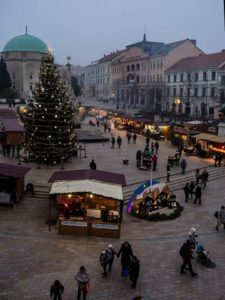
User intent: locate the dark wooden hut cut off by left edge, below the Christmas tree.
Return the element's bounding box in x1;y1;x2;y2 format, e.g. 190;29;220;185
0;163;30;205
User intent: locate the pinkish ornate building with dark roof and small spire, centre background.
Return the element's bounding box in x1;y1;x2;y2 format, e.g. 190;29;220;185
112;35;203;111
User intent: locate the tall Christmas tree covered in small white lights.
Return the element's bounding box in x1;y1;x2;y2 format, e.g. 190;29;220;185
22;54;76;165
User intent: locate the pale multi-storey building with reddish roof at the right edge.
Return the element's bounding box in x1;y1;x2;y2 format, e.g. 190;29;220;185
165;51;225;118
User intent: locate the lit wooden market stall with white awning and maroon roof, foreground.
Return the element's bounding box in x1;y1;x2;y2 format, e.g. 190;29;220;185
49;169;126;238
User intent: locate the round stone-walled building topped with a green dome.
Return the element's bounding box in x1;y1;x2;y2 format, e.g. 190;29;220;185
2;30;48;98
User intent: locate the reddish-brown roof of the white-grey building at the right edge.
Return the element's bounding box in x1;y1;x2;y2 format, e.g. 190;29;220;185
166;52;225;72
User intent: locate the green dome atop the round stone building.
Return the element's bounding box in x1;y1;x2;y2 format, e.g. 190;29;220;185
3;34;48;53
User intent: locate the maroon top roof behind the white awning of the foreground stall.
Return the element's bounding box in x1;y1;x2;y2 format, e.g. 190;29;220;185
49;169;126;186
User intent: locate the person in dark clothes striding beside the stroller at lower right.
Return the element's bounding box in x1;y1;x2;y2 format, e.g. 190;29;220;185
180;240;198;277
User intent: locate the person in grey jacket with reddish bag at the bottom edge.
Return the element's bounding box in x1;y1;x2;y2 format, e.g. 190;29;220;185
75;266;90;300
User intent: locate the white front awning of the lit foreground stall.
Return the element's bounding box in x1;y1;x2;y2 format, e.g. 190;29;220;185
49;179;123;201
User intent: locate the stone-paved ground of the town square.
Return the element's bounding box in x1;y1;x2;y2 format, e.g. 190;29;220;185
0;102;225;300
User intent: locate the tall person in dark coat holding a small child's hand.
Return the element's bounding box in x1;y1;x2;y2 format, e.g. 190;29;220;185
117;242;134;277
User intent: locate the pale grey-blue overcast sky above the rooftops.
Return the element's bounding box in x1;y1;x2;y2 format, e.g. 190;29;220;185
0;0;225;65
